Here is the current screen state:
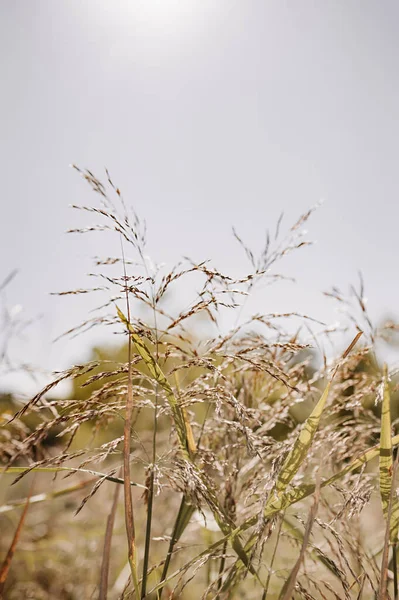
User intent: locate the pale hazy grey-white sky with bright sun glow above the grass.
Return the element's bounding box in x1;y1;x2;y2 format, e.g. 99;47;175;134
0;0;399;396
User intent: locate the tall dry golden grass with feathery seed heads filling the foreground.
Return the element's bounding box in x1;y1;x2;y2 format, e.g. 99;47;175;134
0;169;399;600
